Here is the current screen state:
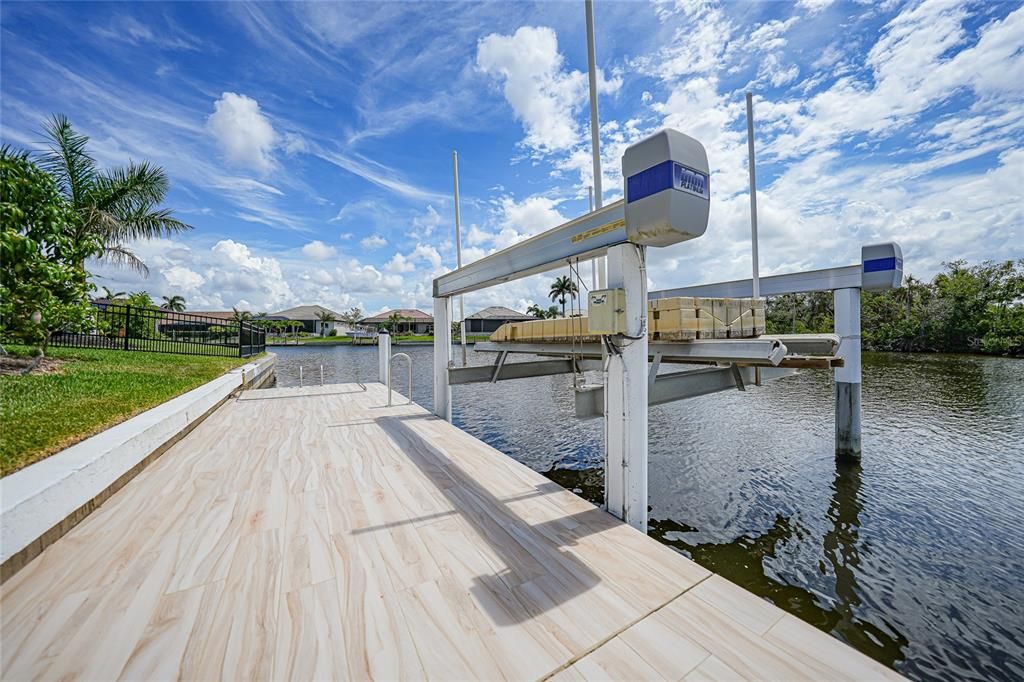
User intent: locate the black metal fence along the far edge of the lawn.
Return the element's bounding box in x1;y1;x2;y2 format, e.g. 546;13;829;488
50;304;266;357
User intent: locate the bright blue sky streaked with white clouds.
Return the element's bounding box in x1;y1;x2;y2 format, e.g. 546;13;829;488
0;0;1024;312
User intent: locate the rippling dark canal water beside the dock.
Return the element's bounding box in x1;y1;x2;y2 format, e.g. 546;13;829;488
272;346;1024;680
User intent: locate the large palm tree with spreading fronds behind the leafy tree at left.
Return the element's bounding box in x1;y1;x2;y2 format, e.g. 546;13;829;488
40;115;191;274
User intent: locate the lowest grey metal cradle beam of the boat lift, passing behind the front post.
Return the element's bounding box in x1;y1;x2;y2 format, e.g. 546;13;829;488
575;366;797;419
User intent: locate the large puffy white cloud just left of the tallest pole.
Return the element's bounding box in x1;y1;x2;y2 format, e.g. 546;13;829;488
476;26;587;152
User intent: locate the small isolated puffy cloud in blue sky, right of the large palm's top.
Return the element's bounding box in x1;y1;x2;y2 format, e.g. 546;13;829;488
206;92;278;173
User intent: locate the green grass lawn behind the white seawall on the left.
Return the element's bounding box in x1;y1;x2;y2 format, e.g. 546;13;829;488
0;346;252;476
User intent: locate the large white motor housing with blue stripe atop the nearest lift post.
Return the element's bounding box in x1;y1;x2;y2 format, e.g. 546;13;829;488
623;129;711;247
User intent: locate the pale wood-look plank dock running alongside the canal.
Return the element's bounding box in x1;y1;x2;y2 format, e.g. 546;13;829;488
0;384;898;680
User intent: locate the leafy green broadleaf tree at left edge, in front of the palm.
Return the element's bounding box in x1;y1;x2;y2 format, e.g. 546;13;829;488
0;146;98;364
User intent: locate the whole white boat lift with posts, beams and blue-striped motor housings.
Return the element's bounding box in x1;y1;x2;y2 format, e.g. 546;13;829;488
411;130;902;531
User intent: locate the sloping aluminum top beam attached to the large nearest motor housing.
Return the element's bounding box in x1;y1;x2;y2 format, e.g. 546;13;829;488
434;200;629;298
